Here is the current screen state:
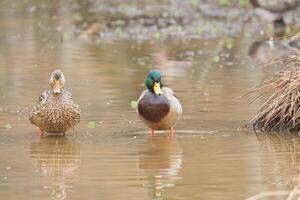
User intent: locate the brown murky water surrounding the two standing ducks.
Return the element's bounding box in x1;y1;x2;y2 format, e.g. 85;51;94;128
0;1;300;200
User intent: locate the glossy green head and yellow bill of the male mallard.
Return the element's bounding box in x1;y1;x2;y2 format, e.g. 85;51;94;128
146;69;163;95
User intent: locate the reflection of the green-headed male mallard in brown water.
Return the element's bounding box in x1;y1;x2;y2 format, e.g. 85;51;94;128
138;137;182;200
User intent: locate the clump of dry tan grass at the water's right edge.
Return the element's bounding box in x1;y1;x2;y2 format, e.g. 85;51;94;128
250;55;300;131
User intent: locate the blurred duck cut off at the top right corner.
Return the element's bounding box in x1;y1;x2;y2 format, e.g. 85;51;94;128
250;0;299;37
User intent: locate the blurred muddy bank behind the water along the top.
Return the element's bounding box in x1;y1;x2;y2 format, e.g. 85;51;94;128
74;0;300;41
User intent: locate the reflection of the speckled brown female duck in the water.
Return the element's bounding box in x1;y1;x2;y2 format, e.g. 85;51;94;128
30;136;80;200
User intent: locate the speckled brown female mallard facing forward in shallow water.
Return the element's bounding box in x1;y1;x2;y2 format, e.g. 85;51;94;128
29;70;80;135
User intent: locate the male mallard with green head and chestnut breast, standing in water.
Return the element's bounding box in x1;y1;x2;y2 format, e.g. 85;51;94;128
137;70;182;137
